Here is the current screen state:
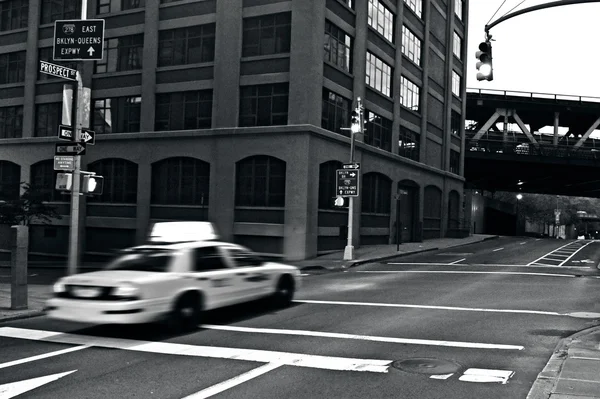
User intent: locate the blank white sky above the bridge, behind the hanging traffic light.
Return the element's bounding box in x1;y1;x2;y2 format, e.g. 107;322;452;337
467;0;600;97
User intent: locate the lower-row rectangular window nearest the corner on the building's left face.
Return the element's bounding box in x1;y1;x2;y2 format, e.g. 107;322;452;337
239;83;289;126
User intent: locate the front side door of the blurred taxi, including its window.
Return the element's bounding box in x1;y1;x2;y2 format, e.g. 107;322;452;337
191;245;244;308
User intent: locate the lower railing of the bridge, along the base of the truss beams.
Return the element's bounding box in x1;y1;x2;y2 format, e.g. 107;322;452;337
466;139;600;161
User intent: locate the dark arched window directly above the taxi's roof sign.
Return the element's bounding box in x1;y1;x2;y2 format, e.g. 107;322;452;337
151;157;210;206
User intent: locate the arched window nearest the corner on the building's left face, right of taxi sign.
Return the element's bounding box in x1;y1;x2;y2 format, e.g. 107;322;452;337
235;155;285;207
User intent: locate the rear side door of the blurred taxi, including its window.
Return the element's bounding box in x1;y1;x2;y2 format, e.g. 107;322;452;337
226;245;274;299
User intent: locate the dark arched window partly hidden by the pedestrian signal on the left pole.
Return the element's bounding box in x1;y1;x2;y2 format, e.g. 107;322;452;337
88;158;137;204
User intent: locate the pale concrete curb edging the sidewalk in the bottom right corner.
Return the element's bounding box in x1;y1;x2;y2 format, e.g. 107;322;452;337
526;326;600;399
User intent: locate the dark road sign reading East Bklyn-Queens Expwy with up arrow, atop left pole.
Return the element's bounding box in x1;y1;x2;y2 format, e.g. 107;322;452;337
54;19;104;61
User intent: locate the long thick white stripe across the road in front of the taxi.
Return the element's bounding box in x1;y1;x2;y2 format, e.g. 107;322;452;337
0;327;392;373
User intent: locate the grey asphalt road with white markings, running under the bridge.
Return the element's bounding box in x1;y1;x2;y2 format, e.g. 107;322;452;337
0;237;600;399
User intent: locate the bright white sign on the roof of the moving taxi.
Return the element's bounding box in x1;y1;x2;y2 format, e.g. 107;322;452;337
148;222;219;243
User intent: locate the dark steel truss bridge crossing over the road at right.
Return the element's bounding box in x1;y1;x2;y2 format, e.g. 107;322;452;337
465;89;600;198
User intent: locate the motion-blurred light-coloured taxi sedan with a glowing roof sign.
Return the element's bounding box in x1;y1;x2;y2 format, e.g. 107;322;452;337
46;222;300;330
